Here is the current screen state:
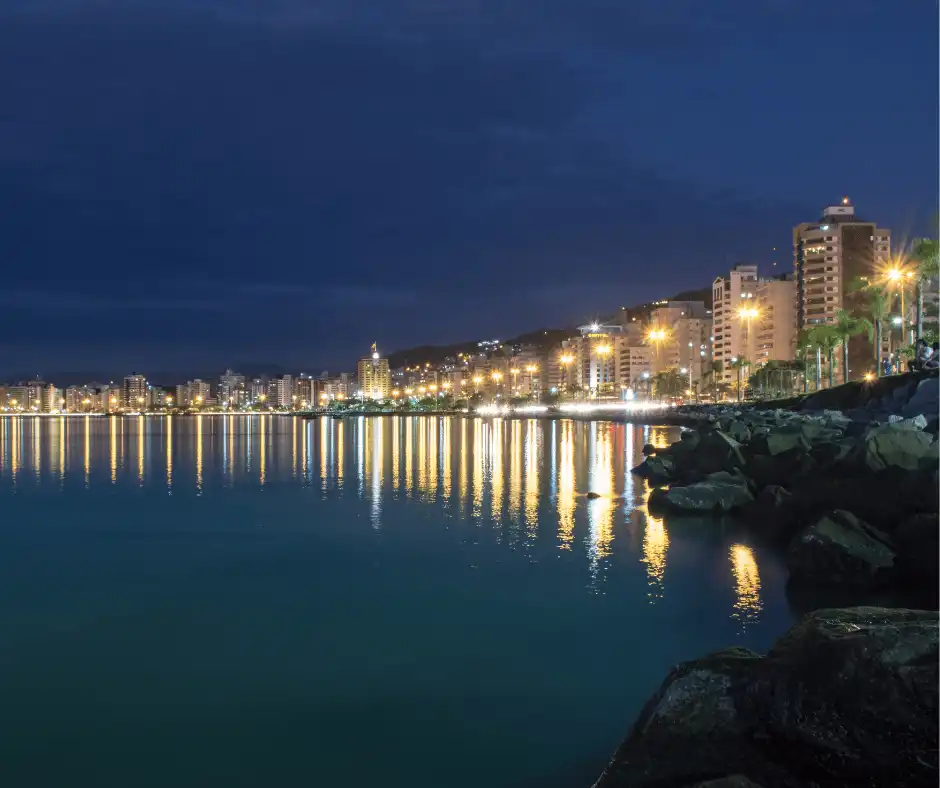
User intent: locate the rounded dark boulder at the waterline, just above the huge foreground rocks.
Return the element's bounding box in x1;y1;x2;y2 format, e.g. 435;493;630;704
787;510;895;587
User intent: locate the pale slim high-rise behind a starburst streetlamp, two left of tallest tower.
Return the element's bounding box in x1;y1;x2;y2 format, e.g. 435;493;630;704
712;265;757;383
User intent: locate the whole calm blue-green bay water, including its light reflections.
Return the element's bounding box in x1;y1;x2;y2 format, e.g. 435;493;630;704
0;416;792;788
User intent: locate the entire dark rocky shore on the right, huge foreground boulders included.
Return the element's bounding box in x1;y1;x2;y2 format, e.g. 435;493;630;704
595;375;940;788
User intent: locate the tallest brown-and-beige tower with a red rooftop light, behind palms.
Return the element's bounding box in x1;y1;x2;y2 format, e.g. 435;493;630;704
793;197;891;370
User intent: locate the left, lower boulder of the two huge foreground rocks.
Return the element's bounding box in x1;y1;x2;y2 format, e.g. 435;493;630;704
595;648;788;788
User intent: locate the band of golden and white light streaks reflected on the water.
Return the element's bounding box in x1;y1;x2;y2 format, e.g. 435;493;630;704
0;414;780;608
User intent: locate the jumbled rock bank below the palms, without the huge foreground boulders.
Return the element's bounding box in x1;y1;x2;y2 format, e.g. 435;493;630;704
633;376;940;605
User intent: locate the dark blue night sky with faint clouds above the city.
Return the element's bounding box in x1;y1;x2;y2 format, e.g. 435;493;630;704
0;0;938;378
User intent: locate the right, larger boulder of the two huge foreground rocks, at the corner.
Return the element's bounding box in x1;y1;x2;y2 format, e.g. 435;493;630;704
735;608;940;788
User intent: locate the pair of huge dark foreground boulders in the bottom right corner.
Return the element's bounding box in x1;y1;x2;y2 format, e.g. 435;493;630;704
595;607;940;788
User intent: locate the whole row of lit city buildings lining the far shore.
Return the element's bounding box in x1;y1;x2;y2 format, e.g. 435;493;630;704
0;198;924;413
